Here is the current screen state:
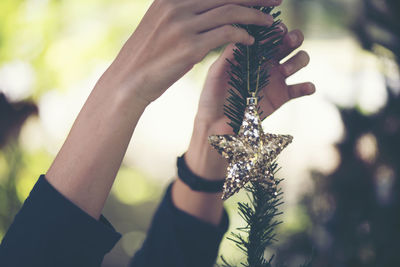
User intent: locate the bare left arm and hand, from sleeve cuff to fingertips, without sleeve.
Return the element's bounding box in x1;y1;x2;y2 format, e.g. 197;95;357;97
46;0;279;218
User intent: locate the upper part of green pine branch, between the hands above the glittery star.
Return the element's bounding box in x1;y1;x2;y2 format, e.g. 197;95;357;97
224;7;282;133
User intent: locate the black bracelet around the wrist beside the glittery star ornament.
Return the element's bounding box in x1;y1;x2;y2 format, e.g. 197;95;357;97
176;154;225;193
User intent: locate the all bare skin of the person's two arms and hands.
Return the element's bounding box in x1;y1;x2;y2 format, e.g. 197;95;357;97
46;0;314;224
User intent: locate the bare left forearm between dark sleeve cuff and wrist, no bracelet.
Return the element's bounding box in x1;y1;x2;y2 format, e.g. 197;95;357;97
46;75;146;219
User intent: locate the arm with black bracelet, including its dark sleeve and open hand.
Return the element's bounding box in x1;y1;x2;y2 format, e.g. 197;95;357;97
131;25;314;267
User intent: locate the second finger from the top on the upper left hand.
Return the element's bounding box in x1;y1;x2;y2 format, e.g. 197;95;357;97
192;4;274;32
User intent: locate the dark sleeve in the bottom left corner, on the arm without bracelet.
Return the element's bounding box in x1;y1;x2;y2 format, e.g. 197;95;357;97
0;175;121;267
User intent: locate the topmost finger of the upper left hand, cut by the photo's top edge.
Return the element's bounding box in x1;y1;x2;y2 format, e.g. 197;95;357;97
191;0;282;14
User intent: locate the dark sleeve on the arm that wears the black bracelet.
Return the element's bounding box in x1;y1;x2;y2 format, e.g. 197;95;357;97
131;184;229;267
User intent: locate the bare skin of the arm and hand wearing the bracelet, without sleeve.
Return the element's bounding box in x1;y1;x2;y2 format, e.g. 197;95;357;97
172;28;315;225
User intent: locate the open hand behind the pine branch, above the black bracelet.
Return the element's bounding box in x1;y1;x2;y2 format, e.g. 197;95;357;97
185;24;315;179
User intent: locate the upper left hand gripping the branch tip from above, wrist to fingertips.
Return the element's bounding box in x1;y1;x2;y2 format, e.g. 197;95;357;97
99;0;282;104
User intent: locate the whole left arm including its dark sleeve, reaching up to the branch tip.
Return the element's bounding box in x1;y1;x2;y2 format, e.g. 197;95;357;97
0;0;280;266
